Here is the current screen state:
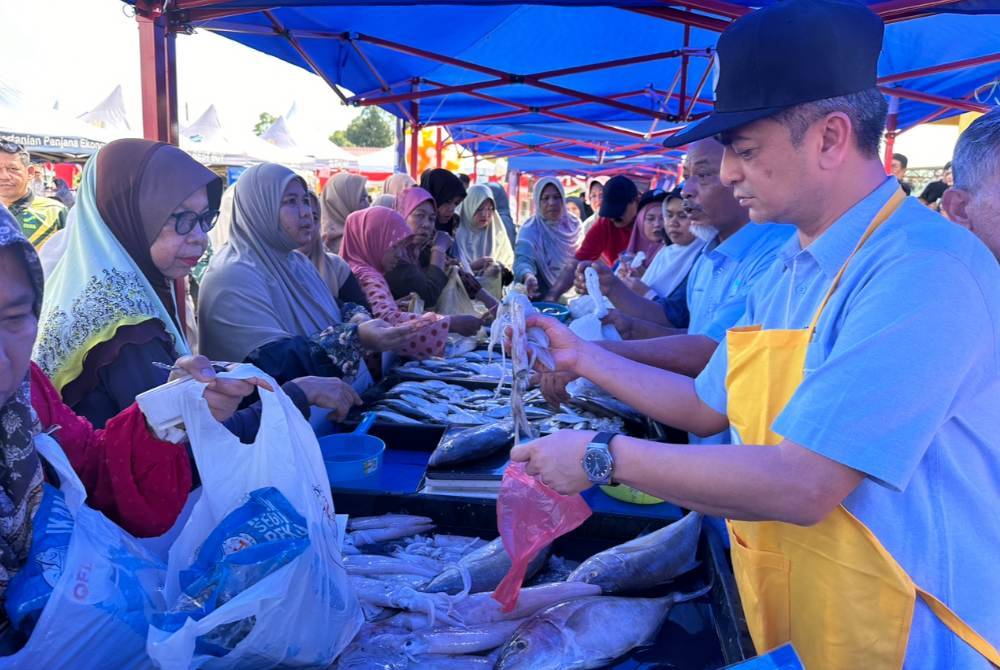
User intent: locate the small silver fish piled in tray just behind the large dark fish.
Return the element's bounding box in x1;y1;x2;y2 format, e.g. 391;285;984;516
369;380;624;433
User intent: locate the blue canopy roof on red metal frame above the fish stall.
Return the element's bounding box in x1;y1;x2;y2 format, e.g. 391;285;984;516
131;0;1000;173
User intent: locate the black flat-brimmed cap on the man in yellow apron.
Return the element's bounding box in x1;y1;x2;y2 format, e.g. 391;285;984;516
663;0;885;147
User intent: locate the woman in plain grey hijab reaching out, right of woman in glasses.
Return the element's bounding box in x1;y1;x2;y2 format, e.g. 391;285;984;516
198;163;422;382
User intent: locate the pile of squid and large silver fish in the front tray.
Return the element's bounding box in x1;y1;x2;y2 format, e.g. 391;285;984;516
336;513;708;670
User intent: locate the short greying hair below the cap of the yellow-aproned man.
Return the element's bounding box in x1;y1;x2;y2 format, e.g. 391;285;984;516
771;88;889;158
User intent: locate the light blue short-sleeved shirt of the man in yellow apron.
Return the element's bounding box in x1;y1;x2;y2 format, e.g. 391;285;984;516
695;178;1000;669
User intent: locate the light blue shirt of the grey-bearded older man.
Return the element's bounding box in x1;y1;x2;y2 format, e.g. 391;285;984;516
687;223;795;444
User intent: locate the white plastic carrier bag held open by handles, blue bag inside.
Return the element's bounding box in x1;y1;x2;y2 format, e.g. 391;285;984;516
148;366;362;670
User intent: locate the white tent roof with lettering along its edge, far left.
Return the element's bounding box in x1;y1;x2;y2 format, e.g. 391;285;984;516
0;81;116;157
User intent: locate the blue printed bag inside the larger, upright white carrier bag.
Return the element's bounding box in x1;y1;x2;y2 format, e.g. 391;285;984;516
153;487;309;656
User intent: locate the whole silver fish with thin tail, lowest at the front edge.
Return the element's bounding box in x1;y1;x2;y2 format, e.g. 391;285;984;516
496;587;710;670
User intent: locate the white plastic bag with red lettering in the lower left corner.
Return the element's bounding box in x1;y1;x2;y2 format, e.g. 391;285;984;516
0;435;165;670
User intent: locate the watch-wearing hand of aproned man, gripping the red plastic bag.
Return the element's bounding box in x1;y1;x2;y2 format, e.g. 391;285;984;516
510;430;597;495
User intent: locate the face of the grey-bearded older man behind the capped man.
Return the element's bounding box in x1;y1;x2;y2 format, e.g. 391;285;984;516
681;139;747;234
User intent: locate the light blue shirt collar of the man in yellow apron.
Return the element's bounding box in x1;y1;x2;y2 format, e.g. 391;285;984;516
778;176;899;279
